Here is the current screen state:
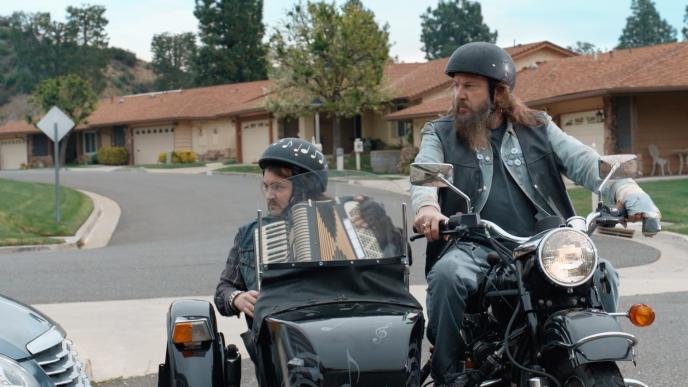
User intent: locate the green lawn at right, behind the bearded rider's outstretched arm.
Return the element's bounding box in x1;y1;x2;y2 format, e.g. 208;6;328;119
569;179;688;234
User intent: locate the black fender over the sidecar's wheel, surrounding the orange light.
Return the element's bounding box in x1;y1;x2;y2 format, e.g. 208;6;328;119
159;300;224;387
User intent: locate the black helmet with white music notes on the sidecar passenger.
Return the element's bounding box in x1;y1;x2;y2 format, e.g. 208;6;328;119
258;137;327;193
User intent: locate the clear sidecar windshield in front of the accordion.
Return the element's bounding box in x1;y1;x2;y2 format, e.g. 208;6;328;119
255;171;405;270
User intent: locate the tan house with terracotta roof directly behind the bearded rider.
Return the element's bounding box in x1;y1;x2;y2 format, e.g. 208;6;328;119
385;42;688;173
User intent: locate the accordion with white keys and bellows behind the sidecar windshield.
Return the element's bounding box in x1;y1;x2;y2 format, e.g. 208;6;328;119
254;198;384;264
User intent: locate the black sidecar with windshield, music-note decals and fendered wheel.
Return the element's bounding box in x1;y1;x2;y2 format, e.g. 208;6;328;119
158;171;424;387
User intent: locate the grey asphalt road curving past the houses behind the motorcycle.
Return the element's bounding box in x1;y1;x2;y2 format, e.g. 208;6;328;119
0;171;676;386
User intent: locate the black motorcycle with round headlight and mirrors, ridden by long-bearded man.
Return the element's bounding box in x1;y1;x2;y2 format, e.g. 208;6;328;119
411;155;660;387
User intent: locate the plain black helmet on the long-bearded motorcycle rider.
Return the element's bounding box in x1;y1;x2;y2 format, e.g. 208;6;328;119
444;42;516;90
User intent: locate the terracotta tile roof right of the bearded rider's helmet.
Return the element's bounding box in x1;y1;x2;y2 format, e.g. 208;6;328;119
515;42;688;104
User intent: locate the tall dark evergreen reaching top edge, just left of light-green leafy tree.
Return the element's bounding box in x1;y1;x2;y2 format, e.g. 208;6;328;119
194;0;267;85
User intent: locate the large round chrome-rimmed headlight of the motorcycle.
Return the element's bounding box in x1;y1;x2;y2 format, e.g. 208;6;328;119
538;228;597;287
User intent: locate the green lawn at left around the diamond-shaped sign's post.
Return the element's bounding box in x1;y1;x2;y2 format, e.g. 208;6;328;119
0;179;93;246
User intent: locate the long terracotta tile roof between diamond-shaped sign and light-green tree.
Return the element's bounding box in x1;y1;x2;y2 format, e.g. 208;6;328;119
81;81;271;128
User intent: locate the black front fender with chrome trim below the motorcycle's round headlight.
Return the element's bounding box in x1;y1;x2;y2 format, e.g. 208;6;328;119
540;310;637;368
